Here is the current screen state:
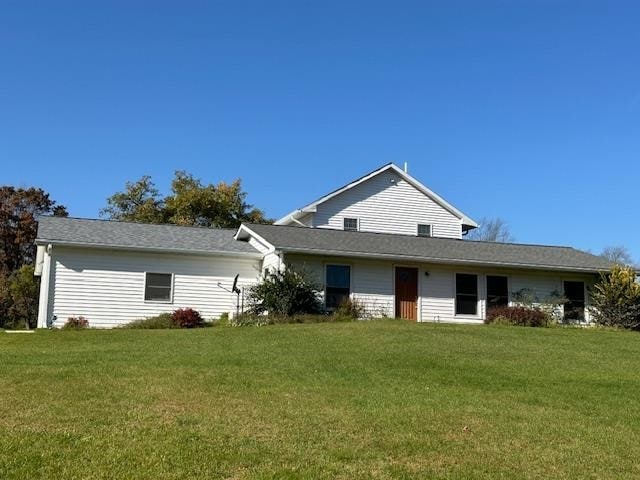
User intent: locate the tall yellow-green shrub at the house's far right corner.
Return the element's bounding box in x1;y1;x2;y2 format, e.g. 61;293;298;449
589;265;640;330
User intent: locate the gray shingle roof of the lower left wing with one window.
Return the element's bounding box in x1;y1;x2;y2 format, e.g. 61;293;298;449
36;217;257;254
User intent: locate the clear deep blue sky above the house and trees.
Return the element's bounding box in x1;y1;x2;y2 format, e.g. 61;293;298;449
0;0;640;259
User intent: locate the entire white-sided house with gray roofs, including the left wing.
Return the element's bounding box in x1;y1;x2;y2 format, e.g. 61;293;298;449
36;164;611;328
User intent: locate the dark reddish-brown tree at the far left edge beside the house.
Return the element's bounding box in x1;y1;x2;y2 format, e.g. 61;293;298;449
0;186;68;275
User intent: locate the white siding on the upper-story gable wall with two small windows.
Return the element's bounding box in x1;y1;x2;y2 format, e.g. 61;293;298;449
313;171;462;238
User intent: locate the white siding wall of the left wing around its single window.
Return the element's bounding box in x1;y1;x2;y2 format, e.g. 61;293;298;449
49;247;260;327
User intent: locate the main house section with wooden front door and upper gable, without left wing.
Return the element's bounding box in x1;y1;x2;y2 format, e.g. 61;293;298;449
236;164;610;323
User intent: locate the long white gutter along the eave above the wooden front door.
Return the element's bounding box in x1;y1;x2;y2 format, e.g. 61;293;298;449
279;247;607;274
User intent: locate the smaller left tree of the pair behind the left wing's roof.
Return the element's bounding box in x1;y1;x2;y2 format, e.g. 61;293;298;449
100;175;164;223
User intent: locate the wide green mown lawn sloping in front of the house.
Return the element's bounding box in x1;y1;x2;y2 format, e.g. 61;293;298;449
0;321;640;480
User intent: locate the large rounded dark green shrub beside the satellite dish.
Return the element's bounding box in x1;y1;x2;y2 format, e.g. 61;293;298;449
247;268;322;316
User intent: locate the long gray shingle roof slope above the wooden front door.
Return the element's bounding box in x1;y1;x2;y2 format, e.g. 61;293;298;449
242;224;611;272
